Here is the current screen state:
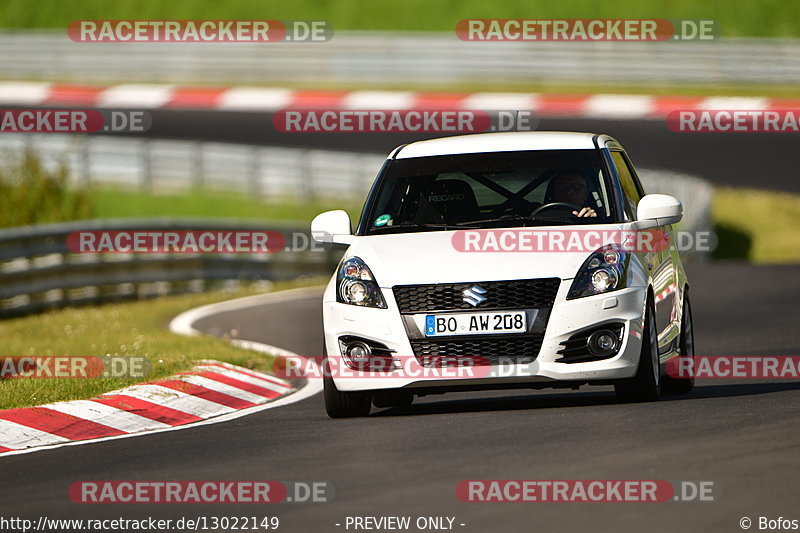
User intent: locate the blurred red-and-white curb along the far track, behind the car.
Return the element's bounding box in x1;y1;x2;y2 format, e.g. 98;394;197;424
0;82;800;119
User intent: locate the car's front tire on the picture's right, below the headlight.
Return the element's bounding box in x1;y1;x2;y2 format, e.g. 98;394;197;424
614;296;661;402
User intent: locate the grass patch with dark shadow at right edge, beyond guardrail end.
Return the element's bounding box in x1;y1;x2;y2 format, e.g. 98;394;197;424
712;187;800;264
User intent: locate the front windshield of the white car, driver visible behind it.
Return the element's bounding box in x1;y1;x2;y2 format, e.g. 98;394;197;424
363;150;617;235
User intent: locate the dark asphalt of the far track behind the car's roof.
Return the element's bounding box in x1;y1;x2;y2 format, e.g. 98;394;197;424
126;109;800;192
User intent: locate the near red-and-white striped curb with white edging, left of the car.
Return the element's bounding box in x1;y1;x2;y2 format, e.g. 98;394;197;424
0;290;321;457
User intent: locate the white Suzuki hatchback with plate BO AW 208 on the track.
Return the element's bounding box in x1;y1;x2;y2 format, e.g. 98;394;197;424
311;132;694;417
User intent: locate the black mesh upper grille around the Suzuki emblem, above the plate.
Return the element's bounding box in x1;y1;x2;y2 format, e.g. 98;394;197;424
392;278;561;313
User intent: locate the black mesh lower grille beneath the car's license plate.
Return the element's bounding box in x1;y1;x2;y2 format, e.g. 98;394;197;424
411;334;544;367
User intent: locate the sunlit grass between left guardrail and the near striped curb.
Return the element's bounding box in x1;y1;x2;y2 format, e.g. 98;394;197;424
0;280;322;409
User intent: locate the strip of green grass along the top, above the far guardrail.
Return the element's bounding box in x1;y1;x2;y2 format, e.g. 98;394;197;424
0;0;800;38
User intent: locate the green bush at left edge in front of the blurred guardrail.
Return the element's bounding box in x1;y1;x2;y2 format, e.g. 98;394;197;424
0;150;95;227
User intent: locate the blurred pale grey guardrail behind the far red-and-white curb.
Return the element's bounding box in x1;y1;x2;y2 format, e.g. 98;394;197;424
0;28;800;88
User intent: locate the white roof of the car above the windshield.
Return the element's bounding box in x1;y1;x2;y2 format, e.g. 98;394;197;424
389;131;607;159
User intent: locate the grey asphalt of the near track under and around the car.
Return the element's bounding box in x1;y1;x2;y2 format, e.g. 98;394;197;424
0;263;800;532
